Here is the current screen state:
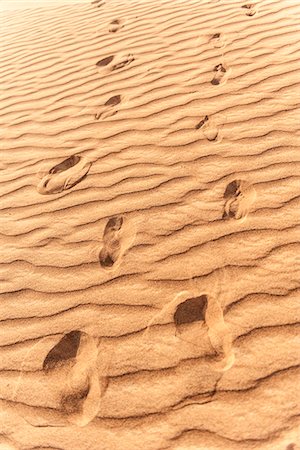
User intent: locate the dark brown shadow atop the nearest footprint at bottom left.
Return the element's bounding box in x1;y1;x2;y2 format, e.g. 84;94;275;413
43;331;81;372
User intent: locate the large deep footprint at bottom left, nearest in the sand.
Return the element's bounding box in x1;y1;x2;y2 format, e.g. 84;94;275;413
43;331;106;426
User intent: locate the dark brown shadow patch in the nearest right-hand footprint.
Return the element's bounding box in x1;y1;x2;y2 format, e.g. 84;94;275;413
174;295;207;328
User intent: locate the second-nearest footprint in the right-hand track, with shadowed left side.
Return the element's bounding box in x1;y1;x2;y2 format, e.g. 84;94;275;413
222;180;256;221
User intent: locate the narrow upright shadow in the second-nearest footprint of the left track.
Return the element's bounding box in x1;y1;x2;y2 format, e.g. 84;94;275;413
99;216;123;269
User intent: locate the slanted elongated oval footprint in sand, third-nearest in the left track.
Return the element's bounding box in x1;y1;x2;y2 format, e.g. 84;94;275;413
37;155;91;194
